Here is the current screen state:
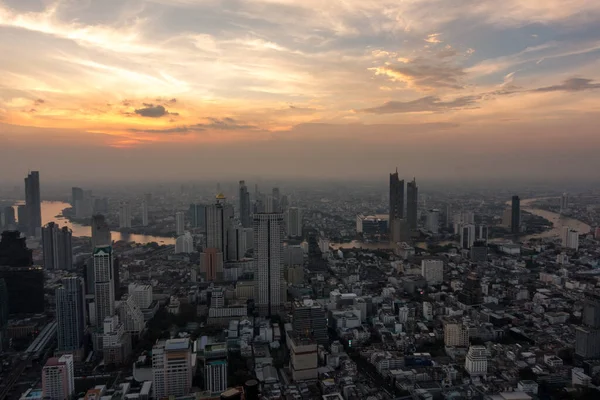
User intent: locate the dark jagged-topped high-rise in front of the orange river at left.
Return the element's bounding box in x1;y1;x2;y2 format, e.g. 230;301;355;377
42;222;73;271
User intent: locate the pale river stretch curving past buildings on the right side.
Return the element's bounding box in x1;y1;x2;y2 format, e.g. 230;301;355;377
330;197;592;250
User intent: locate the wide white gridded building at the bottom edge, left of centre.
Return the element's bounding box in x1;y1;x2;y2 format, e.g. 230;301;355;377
152;338;196;399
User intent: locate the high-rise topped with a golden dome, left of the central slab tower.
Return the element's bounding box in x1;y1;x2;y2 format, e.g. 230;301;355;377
205;193;234;257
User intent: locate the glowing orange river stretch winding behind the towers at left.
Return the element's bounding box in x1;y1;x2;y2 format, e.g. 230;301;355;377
15;201;175;244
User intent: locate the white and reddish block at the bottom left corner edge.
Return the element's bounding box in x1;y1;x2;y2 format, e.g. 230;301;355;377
42;354;75;400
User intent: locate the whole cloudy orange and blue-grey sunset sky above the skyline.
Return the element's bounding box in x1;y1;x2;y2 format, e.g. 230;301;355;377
0;0;600;182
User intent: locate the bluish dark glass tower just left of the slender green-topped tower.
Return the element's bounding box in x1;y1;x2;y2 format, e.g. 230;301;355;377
55;277;86;352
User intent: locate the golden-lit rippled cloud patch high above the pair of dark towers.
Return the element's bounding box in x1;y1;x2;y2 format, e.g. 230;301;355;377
373;58;465;91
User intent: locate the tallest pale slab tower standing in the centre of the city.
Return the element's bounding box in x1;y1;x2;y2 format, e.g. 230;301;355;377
253;214;283;315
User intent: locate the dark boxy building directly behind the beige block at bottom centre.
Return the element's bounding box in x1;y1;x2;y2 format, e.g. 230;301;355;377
292;299;329;346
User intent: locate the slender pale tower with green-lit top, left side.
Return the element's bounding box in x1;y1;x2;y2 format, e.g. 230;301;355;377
93;246;115;324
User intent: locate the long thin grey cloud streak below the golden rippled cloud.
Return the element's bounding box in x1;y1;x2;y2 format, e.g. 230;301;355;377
357;96;481;114
